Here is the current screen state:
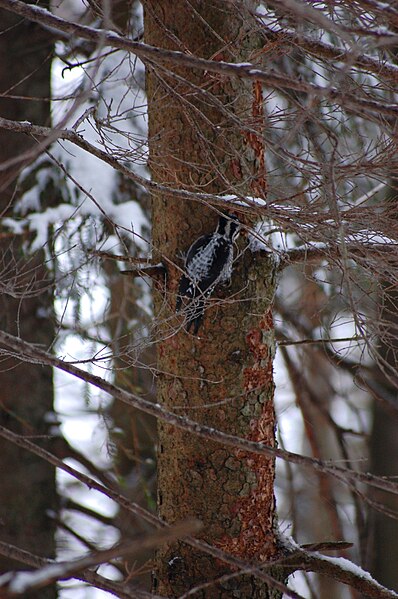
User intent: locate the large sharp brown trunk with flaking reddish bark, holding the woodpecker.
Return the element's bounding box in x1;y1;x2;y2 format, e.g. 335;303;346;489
144;0;278;598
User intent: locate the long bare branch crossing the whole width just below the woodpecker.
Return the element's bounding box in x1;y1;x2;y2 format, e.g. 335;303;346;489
0;331;398;495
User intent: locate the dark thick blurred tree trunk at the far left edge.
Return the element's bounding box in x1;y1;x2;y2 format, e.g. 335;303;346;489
0;5;57;599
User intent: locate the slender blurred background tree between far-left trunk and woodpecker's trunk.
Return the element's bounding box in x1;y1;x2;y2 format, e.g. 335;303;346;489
97;1;156;584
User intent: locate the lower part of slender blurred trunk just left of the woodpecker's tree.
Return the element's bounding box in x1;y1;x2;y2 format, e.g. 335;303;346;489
104;217;156;587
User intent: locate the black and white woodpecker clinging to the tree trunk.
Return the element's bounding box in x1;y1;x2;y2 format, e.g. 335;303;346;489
176;214;240;335
